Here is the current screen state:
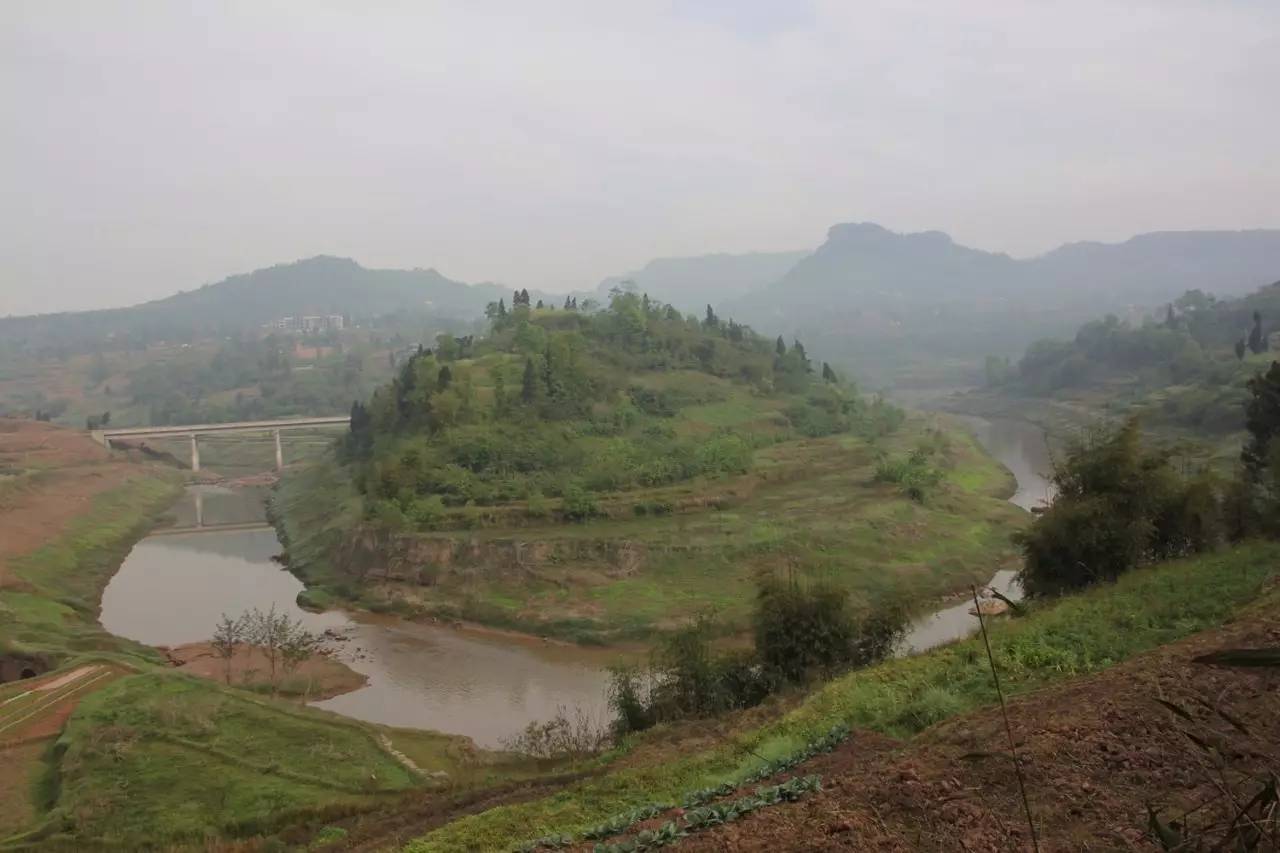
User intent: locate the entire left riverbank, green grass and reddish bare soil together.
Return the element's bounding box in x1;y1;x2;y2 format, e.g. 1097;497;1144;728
0;421;576;849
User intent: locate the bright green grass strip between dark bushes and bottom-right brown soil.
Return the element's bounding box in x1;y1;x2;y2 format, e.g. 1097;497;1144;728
407;543;1280;853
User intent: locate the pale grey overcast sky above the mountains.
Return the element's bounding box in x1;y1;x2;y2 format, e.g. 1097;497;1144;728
0;0;1280;315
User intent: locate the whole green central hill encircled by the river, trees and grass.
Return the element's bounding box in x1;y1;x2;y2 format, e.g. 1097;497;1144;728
276;293;1023;639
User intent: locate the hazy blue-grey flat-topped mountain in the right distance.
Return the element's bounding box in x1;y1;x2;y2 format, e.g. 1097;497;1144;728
718;223;1280;378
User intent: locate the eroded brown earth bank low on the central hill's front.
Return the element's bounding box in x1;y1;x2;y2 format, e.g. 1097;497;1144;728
338;528;666;585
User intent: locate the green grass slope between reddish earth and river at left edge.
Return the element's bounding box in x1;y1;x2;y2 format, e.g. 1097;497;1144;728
0;476;180;660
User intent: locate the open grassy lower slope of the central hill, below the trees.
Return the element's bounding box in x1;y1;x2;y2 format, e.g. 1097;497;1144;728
276;409;1027;639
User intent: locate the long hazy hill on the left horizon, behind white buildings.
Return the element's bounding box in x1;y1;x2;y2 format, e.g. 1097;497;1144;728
0;256;507;351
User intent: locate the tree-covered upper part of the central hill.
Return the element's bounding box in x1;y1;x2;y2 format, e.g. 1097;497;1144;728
344;292;900;529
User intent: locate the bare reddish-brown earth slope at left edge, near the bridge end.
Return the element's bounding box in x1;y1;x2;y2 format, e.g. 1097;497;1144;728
0;418;142;588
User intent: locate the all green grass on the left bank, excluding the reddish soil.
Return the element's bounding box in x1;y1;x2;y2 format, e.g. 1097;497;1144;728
0;450;512;848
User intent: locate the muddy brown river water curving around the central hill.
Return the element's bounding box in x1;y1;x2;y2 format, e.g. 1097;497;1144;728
101;419;1047;747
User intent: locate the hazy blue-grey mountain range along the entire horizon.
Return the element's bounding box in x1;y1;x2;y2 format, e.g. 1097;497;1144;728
10;223;1280;379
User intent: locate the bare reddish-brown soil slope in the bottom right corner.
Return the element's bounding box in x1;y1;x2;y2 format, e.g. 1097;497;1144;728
680;601;1280;852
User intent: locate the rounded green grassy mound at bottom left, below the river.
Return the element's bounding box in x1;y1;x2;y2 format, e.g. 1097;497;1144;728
37;672;417;845
